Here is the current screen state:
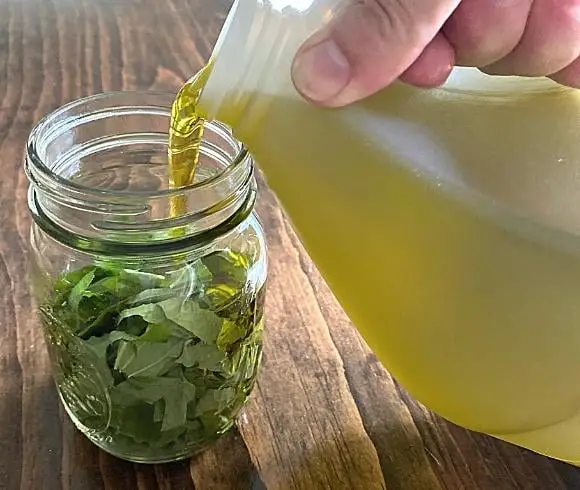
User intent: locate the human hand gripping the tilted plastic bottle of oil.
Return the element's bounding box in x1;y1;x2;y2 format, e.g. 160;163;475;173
292;0;580;107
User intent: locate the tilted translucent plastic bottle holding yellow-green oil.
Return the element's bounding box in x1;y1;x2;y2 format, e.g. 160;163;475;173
200;0;580;463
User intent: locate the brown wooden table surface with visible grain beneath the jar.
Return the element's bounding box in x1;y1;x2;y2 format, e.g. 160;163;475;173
0;0;580;490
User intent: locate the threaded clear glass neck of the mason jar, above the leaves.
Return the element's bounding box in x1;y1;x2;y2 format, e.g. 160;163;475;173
25;91;256;255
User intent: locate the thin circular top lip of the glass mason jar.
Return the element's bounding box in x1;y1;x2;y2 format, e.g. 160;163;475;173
26;90;249;198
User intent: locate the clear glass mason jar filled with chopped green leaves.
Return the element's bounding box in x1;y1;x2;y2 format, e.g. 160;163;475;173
25;92;267;463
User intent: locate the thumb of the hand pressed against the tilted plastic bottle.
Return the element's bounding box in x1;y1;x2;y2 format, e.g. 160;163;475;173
292;0;461;107
